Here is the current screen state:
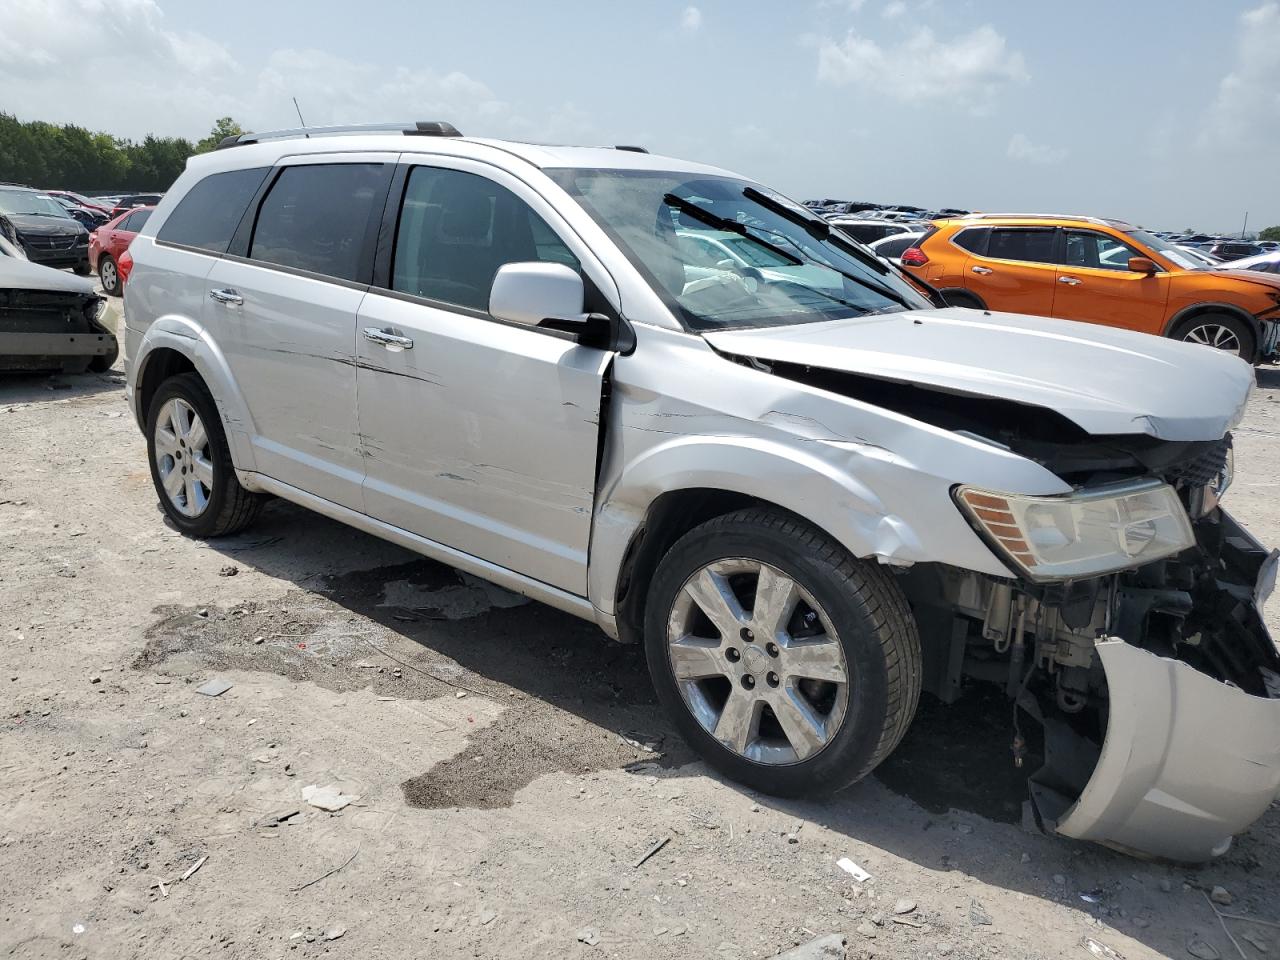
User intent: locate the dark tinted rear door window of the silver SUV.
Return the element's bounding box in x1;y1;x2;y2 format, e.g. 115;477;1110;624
248;164;387;282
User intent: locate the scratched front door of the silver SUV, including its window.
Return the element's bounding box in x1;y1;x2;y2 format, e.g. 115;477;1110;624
356;159;612;595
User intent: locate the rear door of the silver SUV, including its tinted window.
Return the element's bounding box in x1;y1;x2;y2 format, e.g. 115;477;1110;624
205;154;397;509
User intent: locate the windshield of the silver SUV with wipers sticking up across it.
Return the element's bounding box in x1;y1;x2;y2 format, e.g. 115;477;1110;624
547;169;932;330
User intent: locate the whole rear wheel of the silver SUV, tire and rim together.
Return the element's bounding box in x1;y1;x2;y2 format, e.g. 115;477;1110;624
147;372;262;539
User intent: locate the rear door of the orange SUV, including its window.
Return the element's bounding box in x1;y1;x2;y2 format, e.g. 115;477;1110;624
964;227;1060;316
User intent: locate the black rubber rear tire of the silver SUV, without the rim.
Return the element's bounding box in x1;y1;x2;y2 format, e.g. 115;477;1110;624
147;372;265;539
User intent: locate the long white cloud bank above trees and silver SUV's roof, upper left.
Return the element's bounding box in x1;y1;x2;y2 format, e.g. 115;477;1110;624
0;0;599;142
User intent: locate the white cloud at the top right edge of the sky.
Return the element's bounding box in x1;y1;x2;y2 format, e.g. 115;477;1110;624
1199;1;1280;155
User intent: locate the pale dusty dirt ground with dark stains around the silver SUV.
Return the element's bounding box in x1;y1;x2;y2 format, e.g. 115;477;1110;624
0;302;1280;960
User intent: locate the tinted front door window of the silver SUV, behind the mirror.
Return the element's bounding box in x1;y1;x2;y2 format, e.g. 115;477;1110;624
392;166;579;311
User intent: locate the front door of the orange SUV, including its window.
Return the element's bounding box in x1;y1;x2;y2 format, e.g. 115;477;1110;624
1053;229;1169;334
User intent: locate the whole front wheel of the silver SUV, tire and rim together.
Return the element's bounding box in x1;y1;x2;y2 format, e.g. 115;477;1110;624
645;508;922;796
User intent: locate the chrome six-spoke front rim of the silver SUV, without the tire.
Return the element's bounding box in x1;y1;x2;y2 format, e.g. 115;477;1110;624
667;559;849;764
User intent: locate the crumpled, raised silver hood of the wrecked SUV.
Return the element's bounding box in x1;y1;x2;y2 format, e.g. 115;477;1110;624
703;307;1253;440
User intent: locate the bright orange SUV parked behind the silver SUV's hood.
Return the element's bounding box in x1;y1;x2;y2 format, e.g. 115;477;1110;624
902;214;1280;364
